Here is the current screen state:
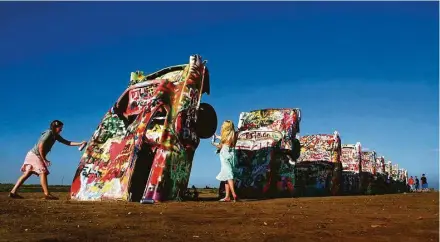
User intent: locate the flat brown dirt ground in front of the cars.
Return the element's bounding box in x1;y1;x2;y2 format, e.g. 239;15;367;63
0;192;439;242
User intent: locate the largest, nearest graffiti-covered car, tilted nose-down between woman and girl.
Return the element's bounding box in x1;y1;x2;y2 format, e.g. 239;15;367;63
70;55;217;203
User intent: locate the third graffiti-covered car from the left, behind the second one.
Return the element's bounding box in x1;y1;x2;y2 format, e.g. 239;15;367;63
295;131;342;196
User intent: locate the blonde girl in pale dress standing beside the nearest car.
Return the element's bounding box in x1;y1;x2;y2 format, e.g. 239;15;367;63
213;120;237;202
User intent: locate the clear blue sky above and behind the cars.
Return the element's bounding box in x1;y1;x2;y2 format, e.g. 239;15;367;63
0;2;439;189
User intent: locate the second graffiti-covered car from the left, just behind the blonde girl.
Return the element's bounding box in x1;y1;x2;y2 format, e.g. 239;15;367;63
219;108;301;198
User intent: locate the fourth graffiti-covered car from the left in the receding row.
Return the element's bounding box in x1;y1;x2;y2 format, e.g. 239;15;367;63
341;142;362;194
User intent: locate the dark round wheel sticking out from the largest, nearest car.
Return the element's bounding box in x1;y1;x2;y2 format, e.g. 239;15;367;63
196;103;217;139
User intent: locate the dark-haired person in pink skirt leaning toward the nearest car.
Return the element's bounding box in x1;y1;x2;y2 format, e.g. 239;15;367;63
9;120;86;200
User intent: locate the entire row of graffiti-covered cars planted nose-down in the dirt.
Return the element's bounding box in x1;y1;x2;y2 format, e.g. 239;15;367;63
70;55;407;203
